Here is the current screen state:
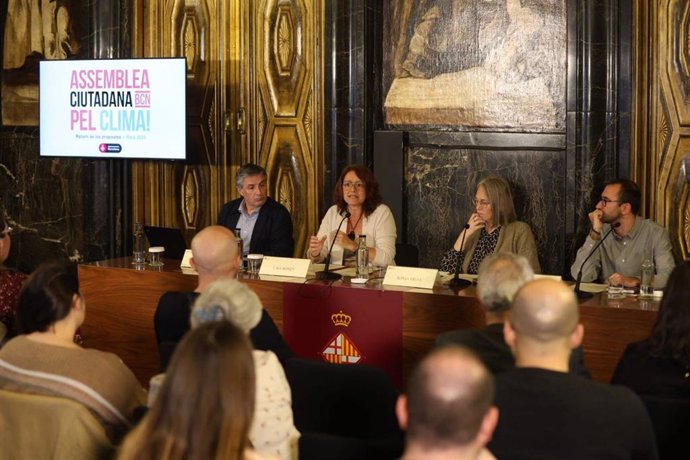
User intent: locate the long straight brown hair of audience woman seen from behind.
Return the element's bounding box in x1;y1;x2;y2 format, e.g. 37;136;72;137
124;321;255;460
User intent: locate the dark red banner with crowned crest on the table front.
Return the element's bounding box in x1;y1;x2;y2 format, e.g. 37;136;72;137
283;283;403;388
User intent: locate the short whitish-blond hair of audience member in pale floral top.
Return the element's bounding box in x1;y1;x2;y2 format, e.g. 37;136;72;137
190;278;263;334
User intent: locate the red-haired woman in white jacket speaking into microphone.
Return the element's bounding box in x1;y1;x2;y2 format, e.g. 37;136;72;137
308;165;396;267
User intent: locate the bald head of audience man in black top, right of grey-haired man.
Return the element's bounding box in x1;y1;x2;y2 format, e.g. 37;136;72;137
504;279;583;371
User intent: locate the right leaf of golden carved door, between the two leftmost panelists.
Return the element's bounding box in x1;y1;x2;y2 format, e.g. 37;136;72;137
250;0;324;255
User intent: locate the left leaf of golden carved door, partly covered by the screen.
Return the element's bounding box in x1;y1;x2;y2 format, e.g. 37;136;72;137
132;0;227;237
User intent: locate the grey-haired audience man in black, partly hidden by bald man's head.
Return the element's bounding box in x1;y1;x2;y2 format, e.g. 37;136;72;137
436;252;591;378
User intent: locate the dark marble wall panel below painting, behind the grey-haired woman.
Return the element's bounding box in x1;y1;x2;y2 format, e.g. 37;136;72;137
405;133;567;273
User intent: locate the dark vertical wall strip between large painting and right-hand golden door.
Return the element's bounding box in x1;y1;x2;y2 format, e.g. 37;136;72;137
564;0;632;261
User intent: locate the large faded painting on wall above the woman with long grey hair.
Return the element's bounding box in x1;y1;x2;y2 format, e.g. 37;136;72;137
383;0;567;132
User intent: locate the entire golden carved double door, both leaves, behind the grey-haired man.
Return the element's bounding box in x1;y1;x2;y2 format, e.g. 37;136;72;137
132;0;323;254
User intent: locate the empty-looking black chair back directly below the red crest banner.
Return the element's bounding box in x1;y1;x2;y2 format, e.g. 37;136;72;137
285;358;403;460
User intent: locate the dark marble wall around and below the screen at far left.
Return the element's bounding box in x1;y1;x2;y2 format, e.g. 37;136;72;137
0;0;131;272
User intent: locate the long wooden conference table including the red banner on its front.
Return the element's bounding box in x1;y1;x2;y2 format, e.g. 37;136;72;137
79;258;658;387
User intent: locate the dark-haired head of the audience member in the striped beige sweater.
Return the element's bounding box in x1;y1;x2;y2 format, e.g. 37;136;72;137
15;262;84;334
